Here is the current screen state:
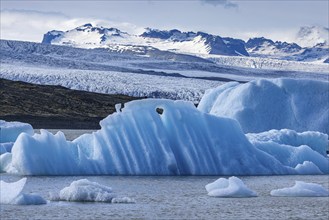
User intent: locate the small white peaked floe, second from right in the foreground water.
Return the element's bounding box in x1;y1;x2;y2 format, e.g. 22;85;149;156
205;176;257;198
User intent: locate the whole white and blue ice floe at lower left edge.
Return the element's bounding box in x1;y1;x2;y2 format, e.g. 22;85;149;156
0;178;47;205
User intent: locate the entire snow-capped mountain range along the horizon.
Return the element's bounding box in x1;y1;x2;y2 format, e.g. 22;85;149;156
42;24;329;63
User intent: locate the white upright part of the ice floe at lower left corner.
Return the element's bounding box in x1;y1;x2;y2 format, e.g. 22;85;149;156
0;178;27;204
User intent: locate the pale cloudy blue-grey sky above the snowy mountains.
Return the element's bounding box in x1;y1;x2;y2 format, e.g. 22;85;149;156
0;0;329;42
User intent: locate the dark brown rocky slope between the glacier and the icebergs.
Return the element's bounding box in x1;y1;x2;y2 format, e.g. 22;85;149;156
0;79;137;129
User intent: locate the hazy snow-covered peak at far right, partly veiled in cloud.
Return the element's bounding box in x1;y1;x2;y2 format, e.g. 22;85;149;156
296;26;329;47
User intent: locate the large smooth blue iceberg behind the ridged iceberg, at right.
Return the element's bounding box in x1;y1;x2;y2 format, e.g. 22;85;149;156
198;78;329;134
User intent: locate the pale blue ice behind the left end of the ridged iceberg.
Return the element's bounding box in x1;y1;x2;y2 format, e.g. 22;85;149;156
0;120;34;143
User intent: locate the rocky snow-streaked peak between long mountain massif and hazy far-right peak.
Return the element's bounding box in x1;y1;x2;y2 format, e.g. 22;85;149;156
245;37;302;58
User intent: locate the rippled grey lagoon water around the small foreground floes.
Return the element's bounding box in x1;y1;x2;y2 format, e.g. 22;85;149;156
0;174;329;220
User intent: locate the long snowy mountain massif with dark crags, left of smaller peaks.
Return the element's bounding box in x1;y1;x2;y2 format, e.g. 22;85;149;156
42;24;248;56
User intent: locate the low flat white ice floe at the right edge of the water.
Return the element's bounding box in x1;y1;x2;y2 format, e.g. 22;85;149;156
271;181;329;197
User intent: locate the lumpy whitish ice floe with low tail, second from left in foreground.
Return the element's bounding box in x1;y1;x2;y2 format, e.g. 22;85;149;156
52;179;135;203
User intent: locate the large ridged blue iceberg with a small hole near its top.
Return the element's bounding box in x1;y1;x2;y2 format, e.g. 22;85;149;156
0;99;329;175
